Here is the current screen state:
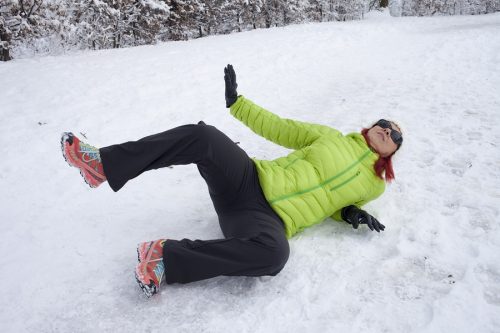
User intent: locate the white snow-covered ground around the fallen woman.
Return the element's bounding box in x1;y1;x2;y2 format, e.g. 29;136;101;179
0;9;500;333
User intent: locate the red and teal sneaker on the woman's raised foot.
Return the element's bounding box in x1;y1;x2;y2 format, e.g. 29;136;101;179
61;132;106;188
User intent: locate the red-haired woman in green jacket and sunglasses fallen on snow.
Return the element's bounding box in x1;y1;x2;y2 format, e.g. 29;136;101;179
61;65;403;297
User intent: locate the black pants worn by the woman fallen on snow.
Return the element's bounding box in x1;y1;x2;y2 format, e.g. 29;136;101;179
100;122;290;283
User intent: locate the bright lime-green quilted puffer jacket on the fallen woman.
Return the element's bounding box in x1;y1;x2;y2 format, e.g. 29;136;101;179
231;96;385;238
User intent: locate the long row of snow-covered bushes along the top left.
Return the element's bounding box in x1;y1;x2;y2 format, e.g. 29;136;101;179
0;0;375;60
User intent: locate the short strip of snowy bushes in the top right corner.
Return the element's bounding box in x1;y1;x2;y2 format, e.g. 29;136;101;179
389;0;500;16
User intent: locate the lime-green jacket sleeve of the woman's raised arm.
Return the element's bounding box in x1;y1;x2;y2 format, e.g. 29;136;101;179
231;96;340;149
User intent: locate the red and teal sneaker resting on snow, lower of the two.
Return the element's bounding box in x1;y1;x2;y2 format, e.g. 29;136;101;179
135;239;166;297
